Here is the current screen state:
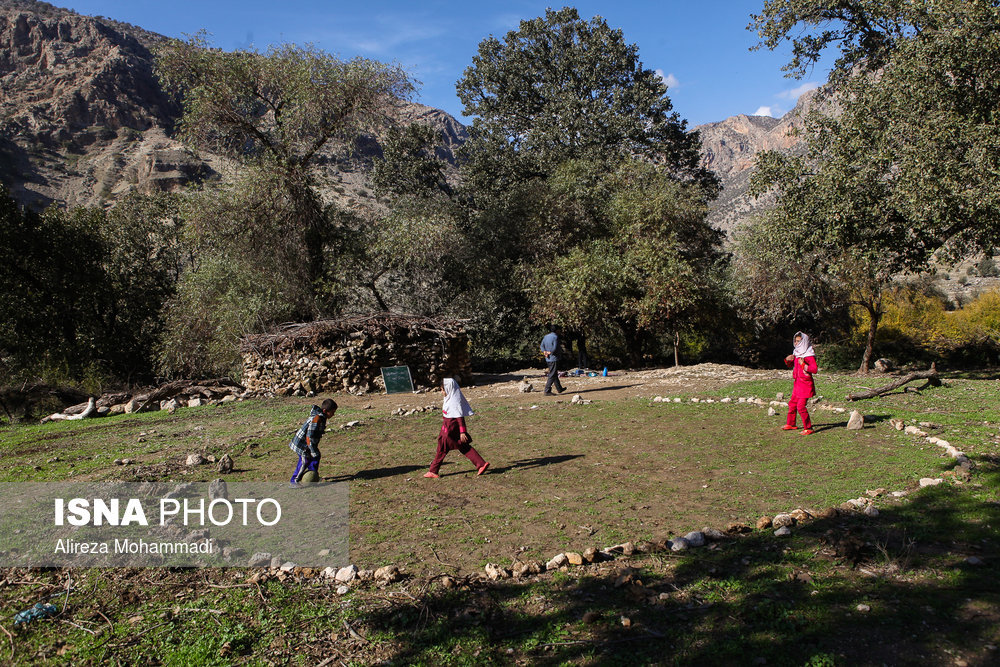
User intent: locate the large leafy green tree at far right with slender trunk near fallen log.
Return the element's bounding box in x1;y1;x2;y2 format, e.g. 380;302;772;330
751;0;1000;371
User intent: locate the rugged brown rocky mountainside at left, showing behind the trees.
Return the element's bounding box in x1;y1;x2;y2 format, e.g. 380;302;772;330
0;0;467;208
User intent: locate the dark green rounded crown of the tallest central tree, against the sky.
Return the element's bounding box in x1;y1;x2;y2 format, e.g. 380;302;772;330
457;8;715;196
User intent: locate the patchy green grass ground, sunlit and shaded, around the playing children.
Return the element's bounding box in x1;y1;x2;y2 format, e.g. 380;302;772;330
0;374;1000;665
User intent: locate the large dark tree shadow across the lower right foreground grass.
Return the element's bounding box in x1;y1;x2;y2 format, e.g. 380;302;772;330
359;457;1000;665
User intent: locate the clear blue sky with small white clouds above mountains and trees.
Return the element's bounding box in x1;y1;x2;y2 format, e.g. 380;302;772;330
60;0;826;125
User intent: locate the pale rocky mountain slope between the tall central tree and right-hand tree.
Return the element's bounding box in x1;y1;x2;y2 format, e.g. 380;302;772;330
694;89;829;232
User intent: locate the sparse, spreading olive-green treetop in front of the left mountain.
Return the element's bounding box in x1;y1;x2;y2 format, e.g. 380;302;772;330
156;34;413;170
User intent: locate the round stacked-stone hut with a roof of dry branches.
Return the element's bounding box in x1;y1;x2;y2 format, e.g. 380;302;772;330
241;314;472;396
